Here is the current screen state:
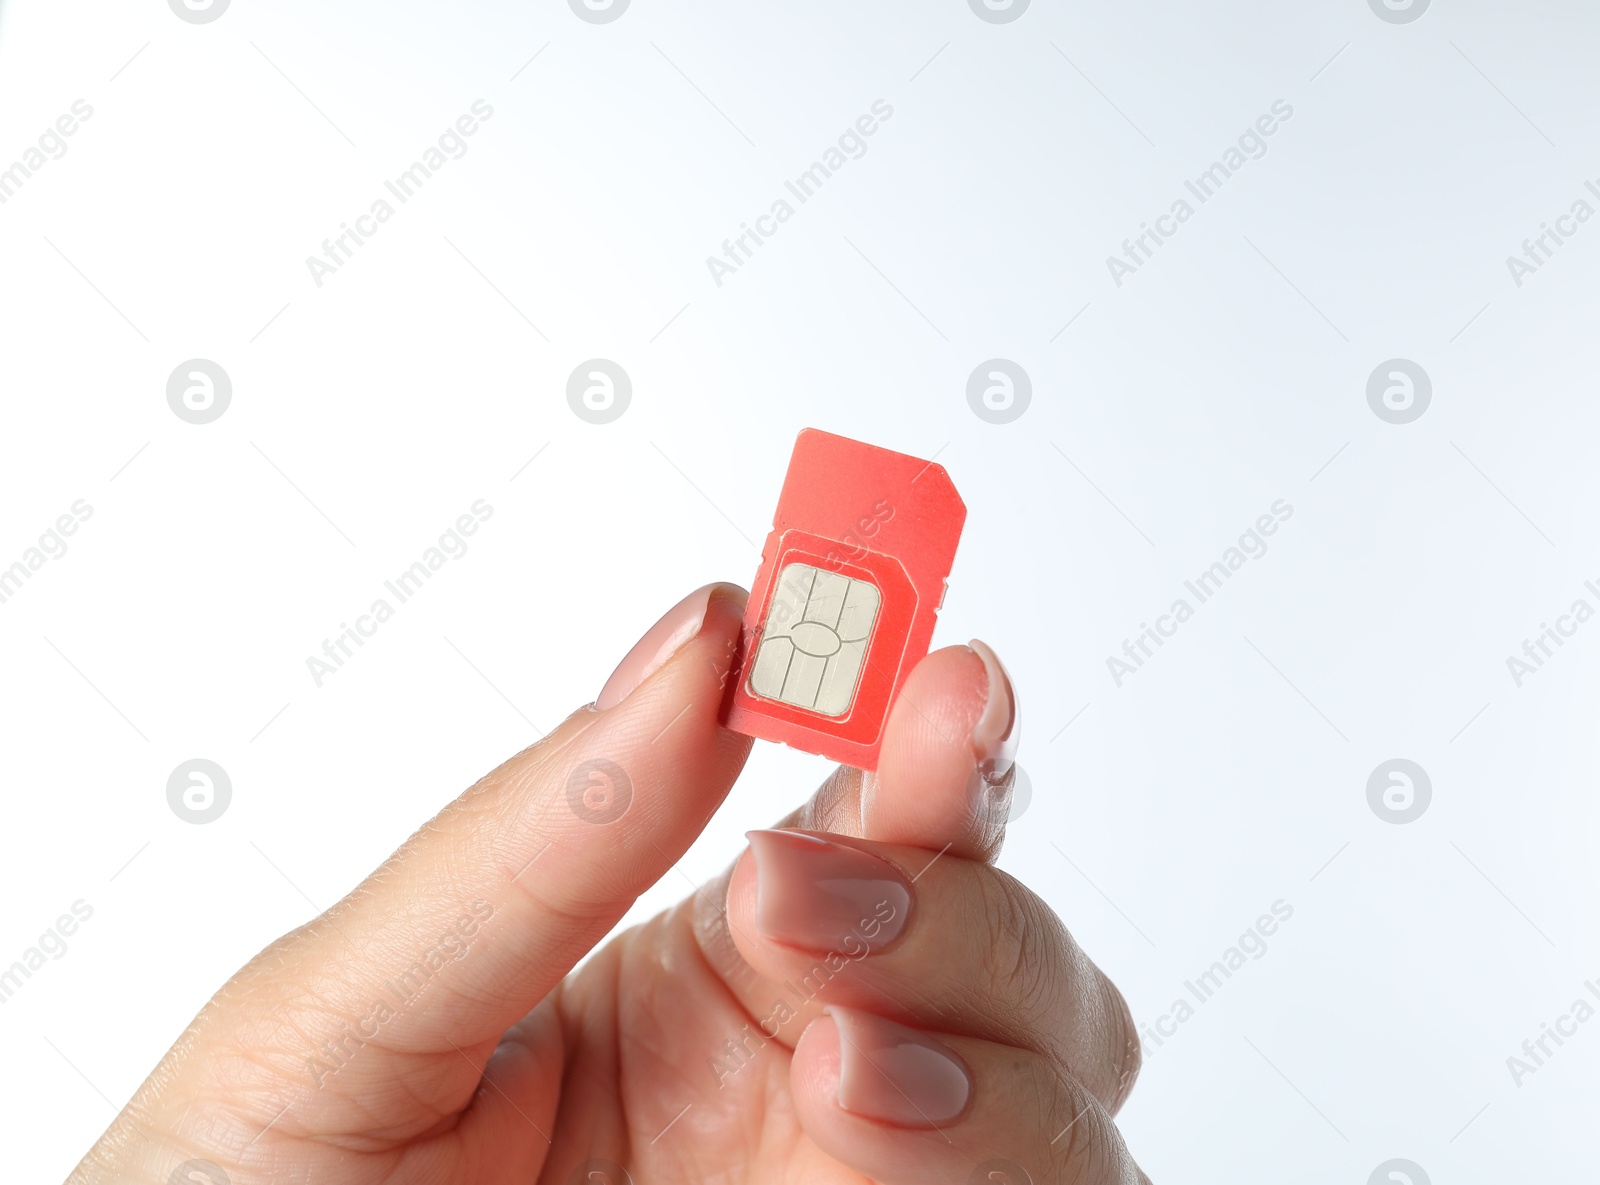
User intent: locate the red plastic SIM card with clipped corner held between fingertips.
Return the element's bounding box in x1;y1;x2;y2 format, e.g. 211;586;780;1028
722;429;966;769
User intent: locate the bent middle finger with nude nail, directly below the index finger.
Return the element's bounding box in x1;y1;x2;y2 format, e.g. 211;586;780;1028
728;832;1139;1111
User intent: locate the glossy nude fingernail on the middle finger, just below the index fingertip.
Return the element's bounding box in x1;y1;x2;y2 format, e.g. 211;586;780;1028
747;832;910;956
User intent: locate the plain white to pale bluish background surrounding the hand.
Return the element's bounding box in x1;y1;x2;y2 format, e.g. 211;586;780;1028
0;0;1600;1183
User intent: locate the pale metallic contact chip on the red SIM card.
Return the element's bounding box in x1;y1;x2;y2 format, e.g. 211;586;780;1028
749;563;882;716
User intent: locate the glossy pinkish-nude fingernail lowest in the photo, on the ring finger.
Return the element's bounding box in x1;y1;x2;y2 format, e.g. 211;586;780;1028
826;1006;973;1127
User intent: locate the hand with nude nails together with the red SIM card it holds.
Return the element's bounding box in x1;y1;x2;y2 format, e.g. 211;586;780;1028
72;432;1152;1185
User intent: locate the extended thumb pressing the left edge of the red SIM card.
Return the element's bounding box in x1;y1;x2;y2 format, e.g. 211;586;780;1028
183;584;750;1129
